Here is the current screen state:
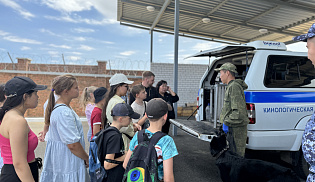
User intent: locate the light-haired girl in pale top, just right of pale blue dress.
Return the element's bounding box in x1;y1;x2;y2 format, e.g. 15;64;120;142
81;86;97;141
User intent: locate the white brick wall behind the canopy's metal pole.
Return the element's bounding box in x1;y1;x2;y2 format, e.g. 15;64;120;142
151;63;207;107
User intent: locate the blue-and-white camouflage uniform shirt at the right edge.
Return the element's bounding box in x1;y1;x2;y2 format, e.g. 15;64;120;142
302;112;315;182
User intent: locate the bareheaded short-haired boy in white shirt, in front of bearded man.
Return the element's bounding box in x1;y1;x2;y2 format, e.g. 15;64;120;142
131;85;150;129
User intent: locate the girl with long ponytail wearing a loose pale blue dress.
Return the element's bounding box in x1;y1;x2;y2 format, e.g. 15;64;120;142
40;75;89;182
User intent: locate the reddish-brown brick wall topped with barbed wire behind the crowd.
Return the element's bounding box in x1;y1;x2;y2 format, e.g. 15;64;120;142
0;58;143;117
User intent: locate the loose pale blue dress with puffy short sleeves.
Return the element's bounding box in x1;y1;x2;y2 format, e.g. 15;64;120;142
40;104;87;182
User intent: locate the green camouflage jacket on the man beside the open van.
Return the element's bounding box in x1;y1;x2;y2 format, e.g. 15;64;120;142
220;79;249;127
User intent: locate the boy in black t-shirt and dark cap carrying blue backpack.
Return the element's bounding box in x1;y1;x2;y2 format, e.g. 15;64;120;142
100;103;140;182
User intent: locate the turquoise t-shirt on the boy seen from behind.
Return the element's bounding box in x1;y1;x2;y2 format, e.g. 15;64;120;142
129;129;178;180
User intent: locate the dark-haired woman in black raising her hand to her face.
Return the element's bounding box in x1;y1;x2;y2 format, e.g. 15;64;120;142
156;80;179;134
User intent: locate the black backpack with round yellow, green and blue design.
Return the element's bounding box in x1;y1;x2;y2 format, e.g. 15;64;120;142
123;130;166;182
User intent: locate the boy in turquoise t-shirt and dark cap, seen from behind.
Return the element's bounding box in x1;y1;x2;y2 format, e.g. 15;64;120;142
123;99;178;182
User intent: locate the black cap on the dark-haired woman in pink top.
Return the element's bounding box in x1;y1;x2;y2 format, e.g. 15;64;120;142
4;76;47;98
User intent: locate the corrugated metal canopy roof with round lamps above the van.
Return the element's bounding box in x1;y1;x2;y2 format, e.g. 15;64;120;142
117;0;315;44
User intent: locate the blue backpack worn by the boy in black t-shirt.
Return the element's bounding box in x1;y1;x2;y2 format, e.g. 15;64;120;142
89;128;114;182
